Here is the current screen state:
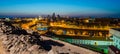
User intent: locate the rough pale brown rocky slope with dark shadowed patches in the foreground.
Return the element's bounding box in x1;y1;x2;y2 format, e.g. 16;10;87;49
0;22;97;54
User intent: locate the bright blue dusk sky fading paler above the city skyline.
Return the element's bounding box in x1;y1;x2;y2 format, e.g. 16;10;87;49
0;0;120;16
